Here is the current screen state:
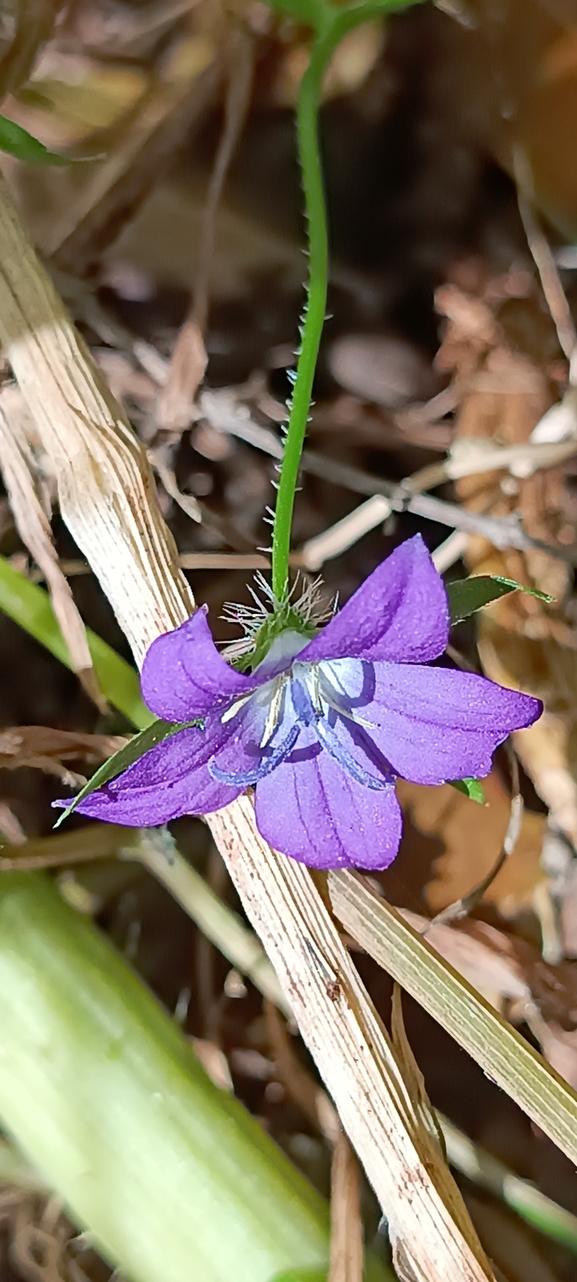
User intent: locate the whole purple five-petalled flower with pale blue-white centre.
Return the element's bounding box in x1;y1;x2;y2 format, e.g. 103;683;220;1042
69;536;542;869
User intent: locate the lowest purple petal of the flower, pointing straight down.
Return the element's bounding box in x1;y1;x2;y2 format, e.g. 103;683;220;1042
256;728;403;869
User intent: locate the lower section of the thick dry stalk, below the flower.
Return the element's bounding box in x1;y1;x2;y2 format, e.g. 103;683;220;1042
209;796;492;1282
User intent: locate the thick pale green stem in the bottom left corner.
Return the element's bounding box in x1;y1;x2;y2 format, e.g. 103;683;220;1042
0;872;330;1282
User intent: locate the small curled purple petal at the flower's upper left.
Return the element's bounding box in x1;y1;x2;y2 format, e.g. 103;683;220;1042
141;606;259;722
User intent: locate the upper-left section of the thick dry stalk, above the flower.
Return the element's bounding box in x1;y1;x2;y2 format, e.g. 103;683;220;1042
0;175;194;662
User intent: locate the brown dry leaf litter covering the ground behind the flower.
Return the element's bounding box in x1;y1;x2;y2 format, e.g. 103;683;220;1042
0;0;577;1282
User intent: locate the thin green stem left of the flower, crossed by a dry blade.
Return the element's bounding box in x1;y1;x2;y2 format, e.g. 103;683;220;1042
0;556;155;729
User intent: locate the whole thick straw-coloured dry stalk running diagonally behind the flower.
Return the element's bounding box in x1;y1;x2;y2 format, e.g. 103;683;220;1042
0;167;492;1282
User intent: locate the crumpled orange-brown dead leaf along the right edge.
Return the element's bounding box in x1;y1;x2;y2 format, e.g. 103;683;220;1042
440;278;577;844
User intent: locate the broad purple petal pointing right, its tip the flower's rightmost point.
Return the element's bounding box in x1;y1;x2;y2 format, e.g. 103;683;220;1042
359;663;542;783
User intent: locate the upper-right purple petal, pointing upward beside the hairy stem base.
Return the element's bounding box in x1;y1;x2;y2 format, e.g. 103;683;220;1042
299;535;449;663
